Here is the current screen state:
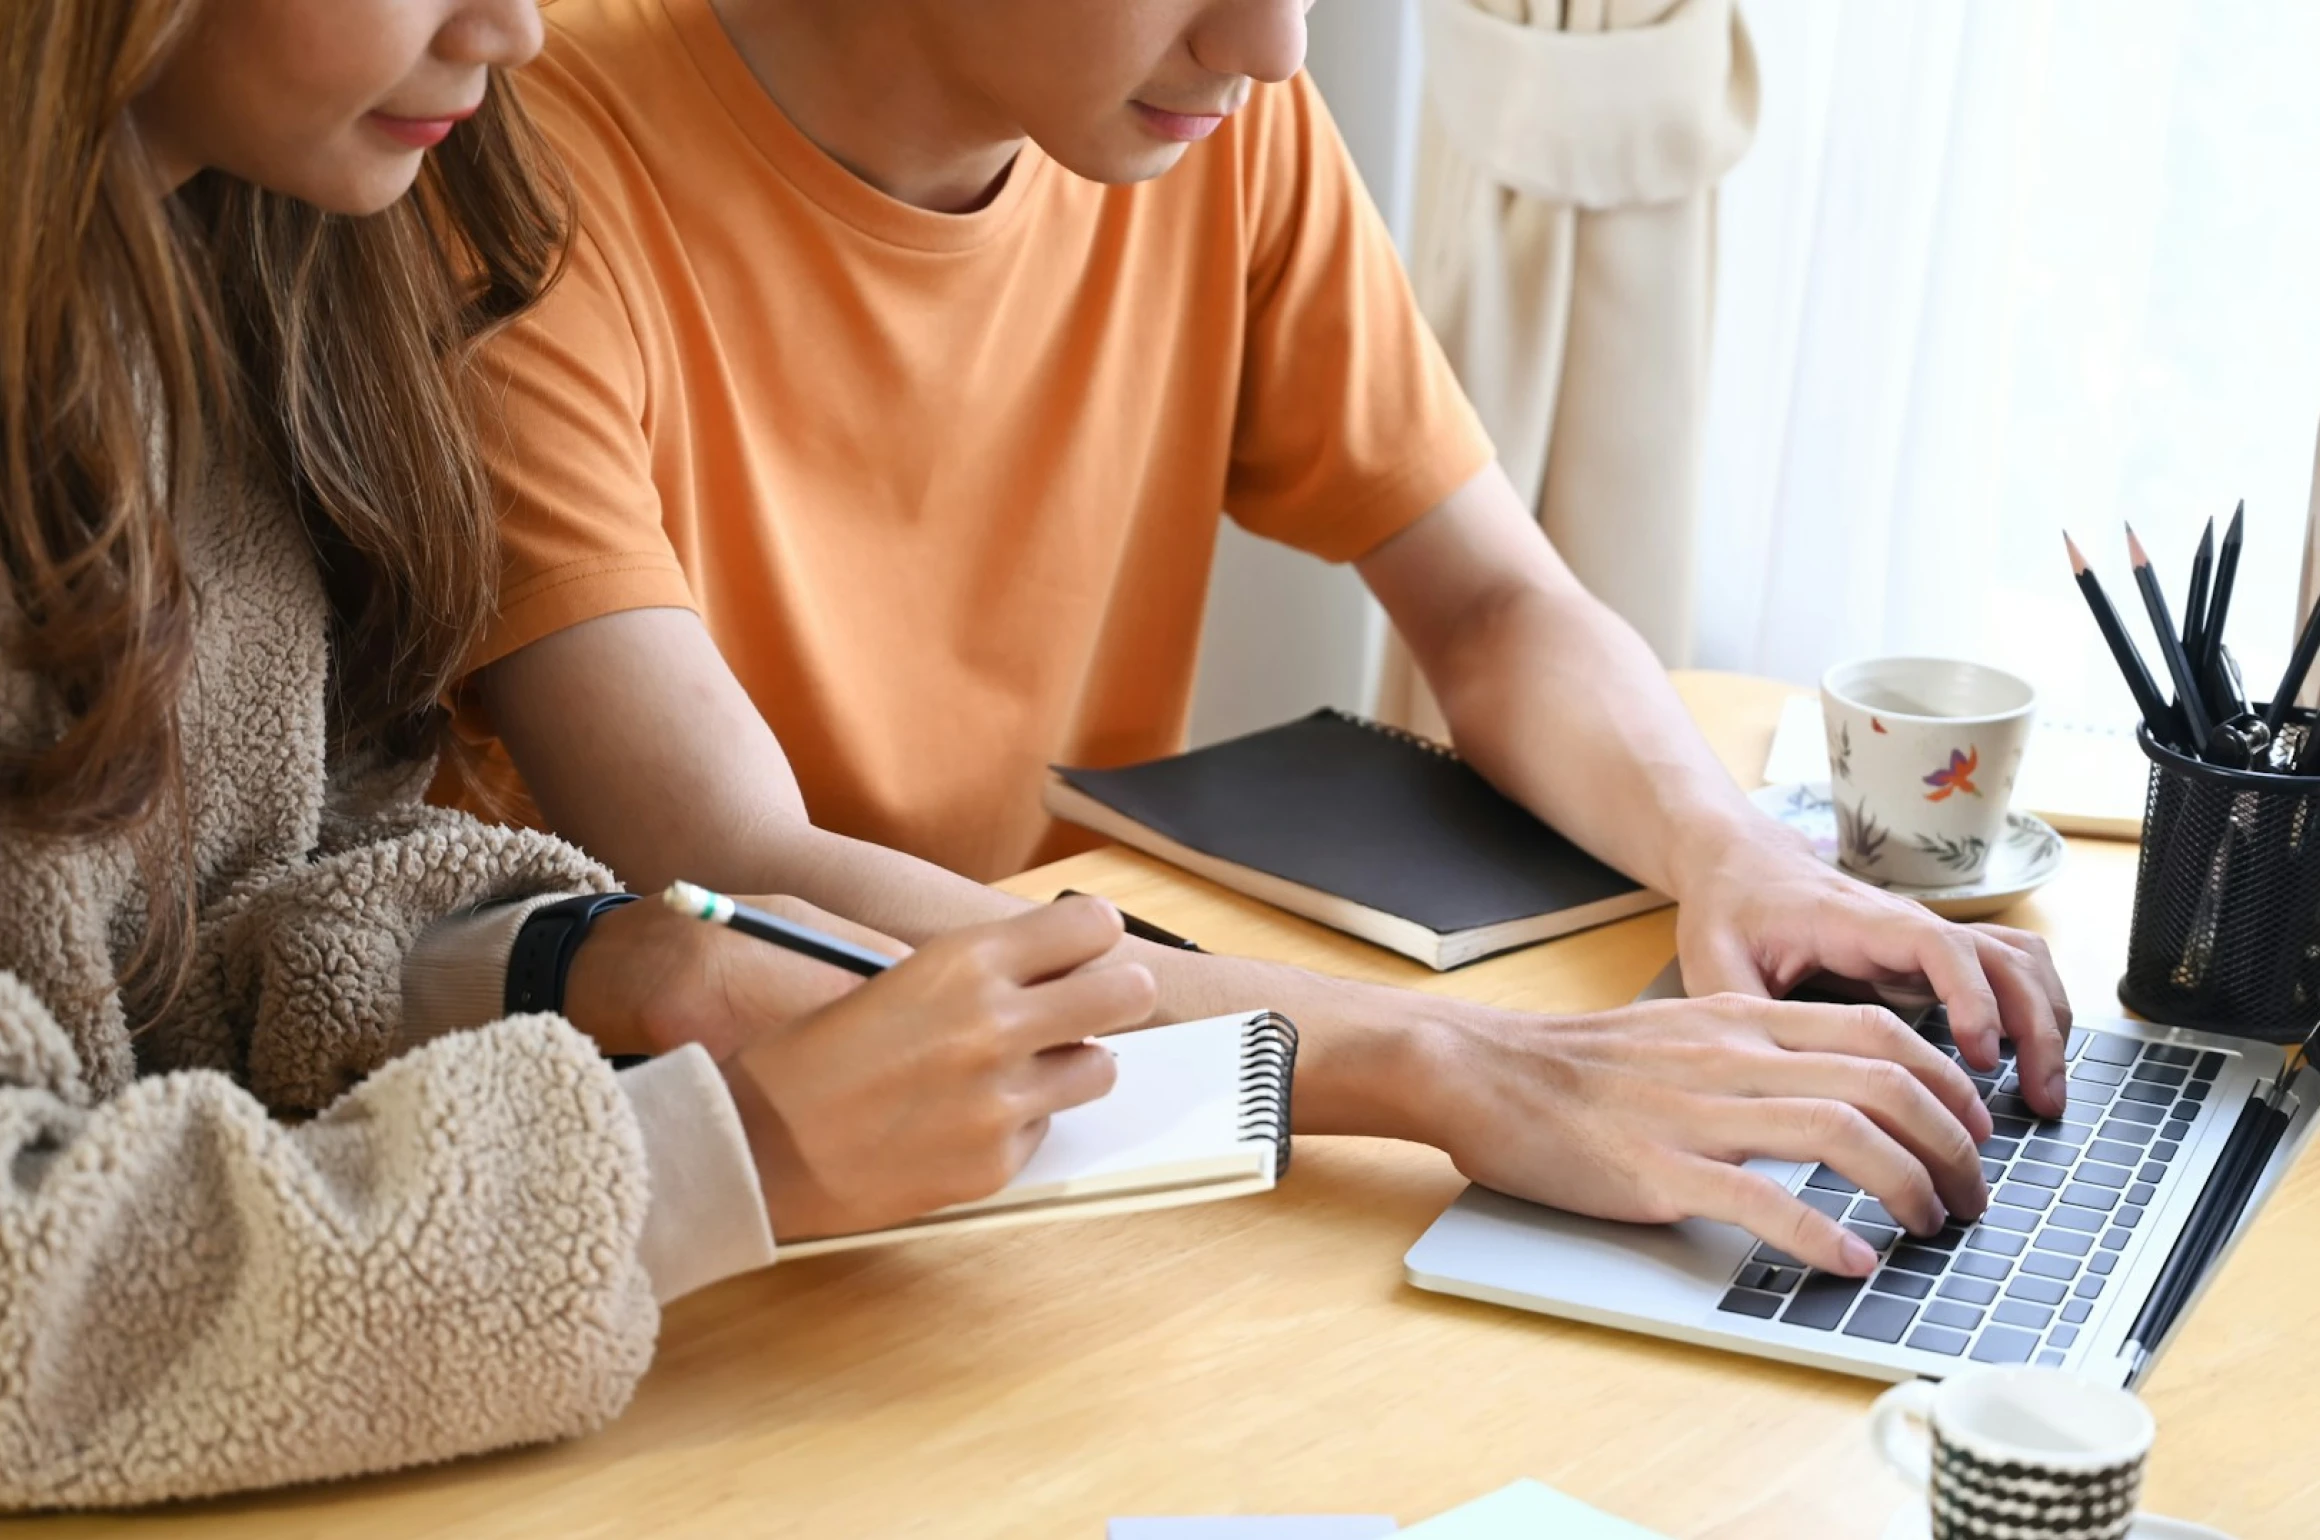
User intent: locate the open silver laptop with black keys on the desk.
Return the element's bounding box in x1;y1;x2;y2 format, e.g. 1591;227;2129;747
1404;990;2320;1385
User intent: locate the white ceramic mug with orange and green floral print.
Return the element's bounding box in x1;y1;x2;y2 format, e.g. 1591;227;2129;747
1821;659;2037;888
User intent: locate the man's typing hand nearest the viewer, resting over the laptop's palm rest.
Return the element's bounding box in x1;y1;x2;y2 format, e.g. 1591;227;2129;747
1422;995;1991;1276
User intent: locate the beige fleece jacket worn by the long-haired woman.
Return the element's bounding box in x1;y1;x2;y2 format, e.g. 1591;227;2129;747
0;459;773;1508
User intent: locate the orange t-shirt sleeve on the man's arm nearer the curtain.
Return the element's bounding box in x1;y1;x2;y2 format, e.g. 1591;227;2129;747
1225;74;1494;561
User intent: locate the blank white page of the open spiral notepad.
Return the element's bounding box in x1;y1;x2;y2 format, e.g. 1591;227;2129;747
944;1014;1274;1213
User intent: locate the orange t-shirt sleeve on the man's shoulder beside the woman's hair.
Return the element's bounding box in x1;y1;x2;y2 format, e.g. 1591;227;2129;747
471;213;694;668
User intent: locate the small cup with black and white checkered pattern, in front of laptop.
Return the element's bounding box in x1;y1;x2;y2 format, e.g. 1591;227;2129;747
1870;1368;2158;1540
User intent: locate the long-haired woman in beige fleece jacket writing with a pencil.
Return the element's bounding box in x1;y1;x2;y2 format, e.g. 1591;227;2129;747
0;0;1151;1508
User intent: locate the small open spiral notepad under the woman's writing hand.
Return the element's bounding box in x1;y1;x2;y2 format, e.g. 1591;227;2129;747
782;1011;1297;1259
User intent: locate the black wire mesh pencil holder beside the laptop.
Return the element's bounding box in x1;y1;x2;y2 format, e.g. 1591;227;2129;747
2118;712;2320;1041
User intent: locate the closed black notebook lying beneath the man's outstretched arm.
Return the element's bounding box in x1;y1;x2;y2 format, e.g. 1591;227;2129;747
1046;710;1668;967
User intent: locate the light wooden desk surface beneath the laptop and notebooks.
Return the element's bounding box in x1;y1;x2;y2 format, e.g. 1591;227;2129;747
40;675;2320;1540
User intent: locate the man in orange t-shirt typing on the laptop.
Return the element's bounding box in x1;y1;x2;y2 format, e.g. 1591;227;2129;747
462;0;2067;1273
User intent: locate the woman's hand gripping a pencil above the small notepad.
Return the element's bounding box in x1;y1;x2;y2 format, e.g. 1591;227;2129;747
724;898;1155;1241
